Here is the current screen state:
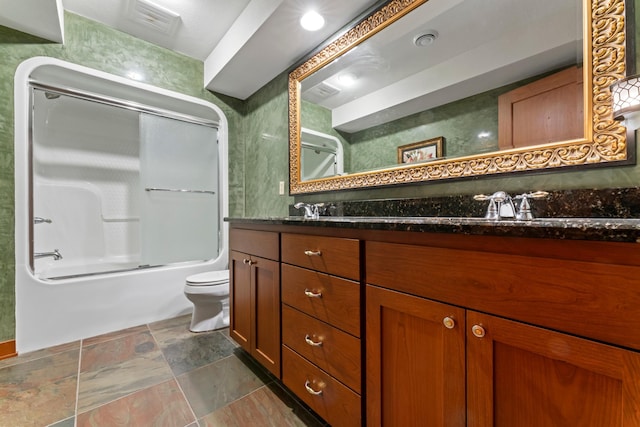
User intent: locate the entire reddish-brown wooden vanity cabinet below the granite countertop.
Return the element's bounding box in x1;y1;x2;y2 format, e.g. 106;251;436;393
230;225;640;427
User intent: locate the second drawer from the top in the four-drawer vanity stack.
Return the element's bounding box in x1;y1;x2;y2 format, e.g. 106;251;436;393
281;264;360;337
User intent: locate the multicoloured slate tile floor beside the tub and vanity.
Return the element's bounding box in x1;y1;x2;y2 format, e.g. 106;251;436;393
0;316;324;427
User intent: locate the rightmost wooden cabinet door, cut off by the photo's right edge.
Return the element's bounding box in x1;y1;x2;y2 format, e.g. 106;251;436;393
467;312;640;427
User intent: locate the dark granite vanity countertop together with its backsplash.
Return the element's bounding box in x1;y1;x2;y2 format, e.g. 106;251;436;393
227;187;640;243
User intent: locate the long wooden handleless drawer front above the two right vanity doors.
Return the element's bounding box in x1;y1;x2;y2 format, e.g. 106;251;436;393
366;242;640;350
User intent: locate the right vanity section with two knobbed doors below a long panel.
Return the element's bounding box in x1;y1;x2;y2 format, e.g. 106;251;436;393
366;239;640;427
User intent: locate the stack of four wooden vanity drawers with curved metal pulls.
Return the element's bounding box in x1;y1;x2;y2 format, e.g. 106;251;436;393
281;233;362;427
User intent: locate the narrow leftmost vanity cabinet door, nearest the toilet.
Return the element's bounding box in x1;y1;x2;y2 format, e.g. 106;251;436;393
229;251;253;353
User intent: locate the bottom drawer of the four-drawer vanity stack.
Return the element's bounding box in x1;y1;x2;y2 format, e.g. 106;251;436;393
282;346;362;427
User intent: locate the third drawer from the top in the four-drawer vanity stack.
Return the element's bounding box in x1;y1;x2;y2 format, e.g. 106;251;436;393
282;305;362;393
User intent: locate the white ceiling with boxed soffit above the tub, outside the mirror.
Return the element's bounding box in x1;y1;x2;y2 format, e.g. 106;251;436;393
0;0;378;99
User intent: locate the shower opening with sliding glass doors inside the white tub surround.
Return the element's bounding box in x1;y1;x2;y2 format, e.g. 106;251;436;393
31;88;219;280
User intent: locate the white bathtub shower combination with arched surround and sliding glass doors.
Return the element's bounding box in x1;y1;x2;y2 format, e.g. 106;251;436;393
15;58;228;352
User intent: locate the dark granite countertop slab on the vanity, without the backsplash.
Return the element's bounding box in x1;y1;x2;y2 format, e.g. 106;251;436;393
227;216;640;242
